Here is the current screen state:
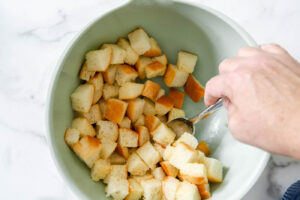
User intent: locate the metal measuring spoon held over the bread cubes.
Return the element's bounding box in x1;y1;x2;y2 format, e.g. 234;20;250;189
167;99;223;137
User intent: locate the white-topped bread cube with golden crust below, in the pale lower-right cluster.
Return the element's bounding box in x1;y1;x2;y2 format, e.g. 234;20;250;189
179;163;208;185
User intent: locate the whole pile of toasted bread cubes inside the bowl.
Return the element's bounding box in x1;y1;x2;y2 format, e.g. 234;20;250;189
65;27;223;200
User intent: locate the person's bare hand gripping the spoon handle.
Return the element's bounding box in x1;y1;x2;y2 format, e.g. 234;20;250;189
205;44;300;160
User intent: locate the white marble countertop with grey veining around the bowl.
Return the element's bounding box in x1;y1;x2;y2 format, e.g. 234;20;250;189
0;0;300;200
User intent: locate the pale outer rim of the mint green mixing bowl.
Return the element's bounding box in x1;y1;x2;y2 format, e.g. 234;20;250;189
45;0;270;200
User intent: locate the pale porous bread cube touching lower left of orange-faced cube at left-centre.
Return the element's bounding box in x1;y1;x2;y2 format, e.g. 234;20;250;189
96;120;119;141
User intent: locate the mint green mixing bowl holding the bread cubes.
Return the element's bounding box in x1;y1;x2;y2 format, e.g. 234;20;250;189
46;1;269;200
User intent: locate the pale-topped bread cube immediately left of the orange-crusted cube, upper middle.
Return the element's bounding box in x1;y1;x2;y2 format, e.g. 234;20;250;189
119;82;144;100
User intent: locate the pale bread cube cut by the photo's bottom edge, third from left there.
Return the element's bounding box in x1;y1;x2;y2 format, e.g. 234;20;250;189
141;179;162;200
